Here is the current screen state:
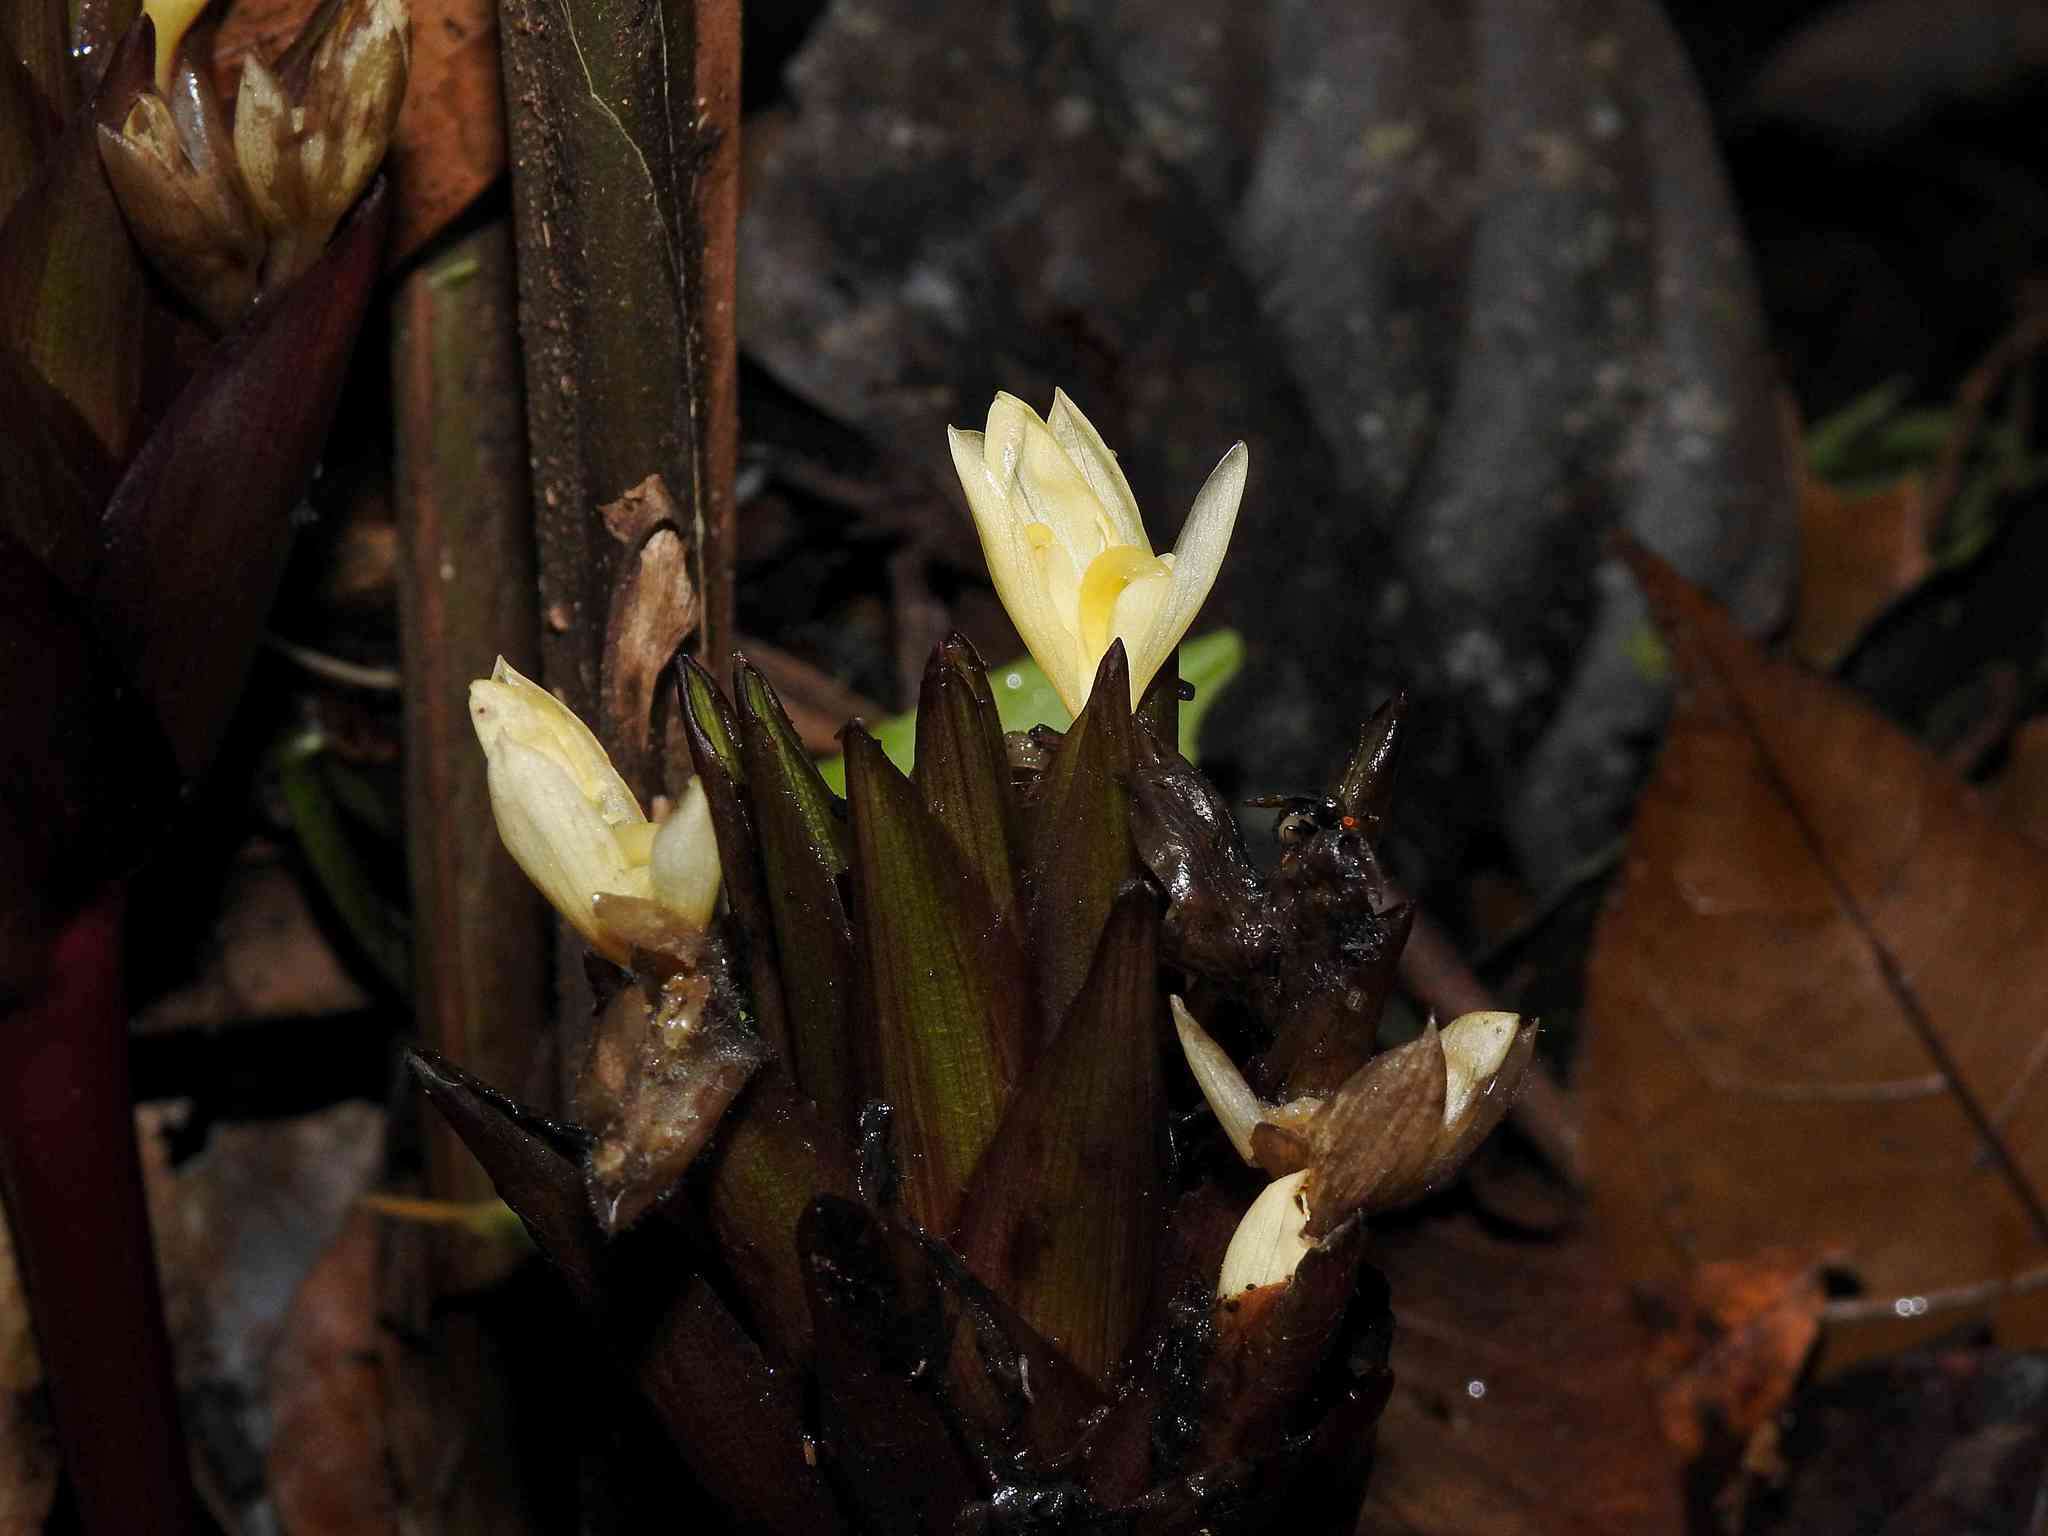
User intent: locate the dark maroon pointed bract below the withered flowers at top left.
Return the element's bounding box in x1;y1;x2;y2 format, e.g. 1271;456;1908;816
92;178;391;772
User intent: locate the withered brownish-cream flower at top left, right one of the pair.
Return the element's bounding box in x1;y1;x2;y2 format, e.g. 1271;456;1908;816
236;0;412;287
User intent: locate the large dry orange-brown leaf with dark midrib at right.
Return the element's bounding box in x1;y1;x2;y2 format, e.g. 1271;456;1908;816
1583;557;2048;1368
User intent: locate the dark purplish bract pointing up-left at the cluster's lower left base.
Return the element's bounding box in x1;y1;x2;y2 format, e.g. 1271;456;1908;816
408;1051;840;1536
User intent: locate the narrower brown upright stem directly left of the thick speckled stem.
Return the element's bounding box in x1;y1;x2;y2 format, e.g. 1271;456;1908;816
391;221;553;1196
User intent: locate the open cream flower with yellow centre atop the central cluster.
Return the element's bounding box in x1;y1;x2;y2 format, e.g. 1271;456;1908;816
946;391;1247;715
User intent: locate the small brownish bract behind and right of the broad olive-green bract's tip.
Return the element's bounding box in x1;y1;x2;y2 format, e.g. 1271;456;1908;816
911;635;1018;924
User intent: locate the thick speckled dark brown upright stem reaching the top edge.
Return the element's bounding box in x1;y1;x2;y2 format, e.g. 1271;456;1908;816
502;0;739;1097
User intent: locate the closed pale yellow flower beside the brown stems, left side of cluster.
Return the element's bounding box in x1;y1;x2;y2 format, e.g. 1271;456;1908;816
469;657;719;963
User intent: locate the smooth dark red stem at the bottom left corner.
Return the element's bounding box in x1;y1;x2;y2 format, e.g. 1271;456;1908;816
0;887;203;1536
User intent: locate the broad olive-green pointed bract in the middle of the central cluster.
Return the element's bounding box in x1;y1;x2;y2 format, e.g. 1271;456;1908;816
846;729;1022;1233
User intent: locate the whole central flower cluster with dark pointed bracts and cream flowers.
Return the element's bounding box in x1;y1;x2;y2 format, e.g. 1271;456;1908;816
444;395;1534;1532
